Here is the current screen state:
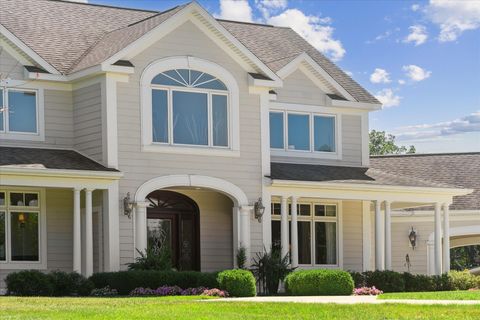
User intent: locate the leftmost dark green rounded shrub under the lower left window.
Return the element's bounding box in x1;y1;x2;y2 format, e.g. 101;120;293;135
5;270;53;296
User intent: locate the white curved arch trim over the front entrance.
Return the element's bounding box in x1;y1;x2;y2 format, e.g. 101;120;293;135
135;174;248;208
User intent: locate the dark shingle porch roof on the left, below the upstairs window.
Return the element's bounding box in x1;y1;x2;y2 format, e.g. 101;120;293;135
0;147;118;172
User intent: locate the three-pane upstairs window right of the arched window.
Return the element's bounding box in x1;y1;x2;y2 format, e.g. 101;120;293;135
270;111;337;153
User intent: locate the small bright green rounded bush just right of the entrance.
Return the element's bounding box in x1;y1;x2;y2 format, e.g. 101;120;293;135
217;269;257;297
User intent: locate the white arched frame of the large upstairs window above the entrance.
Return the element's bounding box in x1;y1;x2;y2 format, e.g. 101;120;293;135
140;56;240;157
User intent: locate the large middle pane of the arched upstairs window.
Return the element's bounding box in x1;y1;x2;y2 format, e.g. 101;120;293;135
173;91;208;145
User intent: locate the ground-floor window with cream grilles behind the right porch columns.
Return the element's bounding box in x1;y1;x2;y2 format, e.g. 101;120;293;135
272;202;338;265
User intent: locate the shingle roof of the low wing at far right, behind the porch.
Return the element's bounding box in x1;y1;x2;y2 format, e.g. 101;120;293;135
370;152;480;210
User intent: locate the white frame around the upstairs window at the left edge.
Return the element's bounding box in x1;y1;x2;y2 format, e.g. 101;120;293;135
0;87;45;141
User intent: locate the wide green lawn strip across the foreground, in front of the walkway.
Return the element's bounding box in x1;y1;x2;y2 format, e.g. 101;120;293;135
0;297;480;320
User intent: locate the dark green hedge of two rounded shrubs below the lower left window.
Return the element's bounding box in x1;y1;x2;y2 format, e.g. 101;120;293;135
5;270;93;297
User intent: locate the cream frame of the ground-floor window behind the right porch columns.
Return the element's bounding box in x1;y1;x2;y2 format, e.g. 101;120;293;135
270;200;343;269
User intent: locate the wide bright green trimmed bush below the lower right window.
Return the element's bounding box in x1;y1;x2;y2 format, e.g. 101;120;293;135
285;269;354;296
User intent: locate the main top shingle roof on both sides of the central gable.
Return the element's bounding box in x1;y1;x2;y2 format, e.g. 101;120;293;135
0;0;379;104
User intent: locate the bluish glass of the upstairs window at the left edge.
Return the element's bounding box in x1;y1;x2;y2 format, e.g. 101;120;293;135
0;88;39;134
